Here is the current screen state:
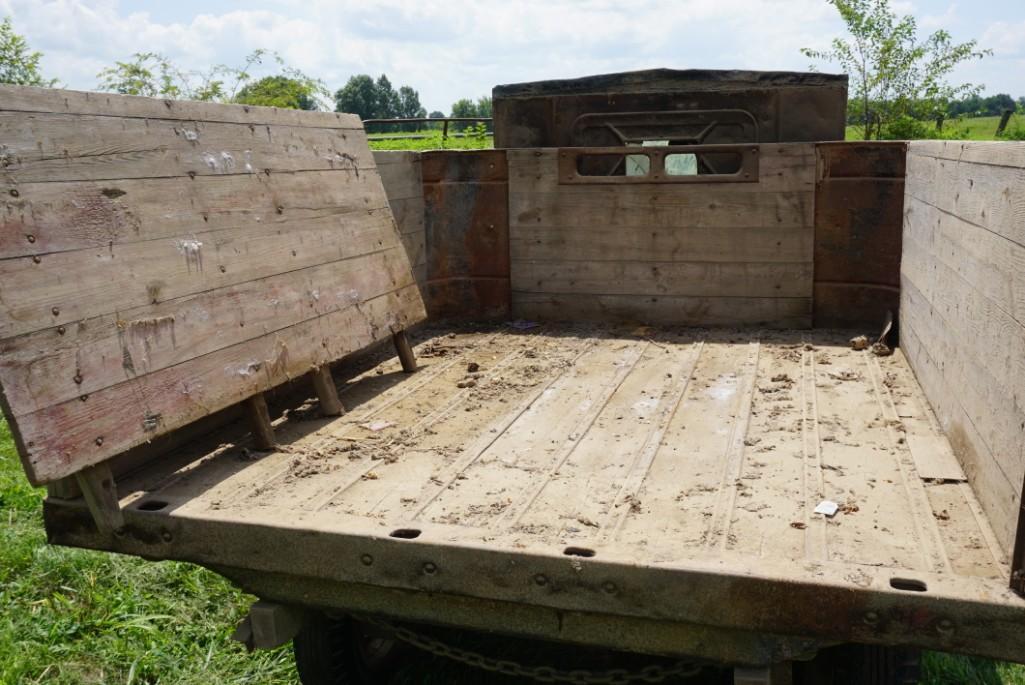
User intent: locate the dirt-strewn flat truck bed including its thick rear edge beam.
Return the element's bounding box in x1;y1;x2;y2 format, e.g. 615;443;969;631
48;324;1021;660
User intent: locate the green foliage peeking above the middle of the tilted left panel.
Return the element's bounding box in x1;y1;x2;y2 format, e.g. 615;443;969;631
97;49;327;110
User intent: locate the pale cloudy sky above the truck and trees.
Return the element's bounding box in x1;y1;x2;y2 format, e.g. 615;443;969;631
0;0;1025;113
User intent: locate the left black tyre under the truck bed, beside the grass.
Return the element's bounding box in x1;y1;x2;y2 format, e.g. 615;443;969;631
292;613;408;685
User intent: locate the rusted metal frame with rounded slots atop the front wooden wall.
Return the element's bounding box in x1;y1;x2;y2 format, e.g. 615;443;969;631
559;145;760;186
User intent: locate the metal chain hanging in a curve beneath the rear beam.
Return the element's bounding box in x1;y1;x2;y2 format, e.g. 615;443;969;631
359;616;701;685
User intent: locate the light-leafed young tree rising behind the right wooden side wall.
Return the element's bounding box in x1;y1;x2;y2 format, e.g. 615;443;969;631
802;0;991;139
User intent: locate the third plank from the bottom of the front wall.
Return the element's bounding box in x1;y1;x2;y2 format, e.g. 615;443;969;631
509;223;815;264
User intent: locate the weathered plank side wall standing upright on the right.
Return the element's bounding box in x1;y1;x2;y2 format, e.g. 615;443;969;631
901;142;1025;553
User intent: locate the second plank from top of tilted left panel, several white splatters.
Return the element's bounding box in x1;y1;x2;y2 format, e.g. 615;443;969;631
0;112;375;184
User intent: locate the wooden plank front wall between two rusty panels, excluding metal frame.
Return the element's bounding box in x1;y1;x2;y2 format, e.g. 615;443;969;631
508;145;816;327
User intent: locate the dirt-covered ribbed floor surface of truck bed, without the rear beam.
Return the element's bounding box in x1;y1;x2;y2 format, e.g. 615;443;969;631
119;322;1008;590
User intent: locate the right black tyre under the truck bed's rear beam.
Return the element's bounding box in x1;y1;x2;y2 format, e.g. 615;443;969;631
793;645;921;685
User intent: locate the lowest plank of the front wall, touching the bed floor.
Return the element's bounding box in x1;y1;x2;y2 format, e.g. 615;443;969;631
513;291;812;328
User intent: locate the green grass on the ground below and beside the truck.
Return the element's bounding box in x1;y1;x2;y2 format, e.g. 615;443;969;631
0;420;1025;685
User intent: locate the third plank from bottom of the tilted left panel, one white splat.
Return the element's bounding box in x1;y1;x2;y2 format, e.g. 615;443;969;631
0;208;404;337
